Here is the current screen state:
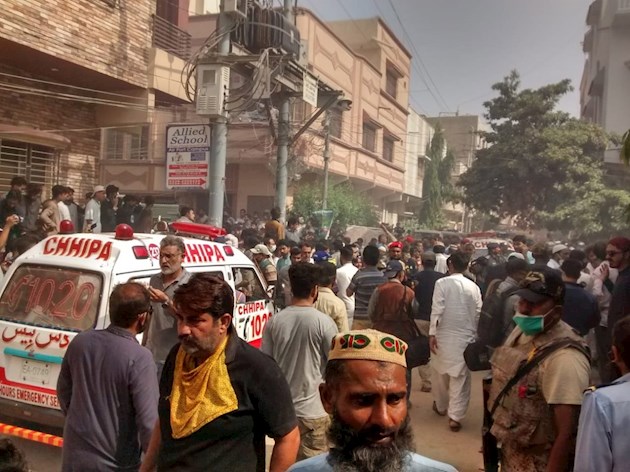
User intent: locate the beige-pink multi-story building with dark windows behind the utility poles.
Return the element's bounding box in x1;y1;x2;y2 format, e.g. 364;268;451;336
189;8;417;222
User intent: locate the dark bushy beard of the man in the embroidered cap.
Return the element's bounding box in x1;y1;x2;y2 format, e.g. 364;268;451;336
328;411;415;472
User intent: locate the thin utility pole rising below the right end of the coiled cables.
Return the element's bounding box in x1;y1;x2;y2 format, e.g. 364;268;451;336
276;0;294;222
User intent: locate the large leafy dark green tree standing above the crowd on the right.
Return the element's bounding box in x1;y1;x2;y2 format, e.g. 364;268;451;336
459;71;623;235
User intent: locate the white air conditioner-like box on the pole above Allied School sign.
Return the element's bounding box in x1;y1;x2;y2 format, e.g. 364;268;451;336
195;64;230;118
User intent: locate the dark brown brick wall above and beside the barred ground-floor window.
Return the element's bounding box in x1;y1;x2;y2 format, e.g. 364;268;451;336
0;65;100;201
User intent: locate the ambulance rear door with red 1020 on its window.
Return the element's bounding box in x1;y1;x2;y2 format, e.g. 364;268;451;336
0;259;108;424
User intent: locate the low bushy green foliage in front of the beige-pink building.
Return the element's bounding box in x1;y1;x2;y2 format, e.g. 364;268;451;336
290;183;378;232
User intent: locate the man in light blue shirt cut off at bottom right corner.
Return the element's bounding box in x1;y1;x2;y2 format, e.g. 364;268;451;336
574;316;630;472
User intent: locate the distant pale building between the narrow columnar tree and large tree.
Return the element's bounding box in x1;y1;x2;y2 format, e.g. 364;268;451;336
427;115;487;232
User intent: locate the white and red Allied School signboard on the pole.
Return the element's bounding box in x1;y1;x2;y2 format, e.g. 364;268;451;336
166;125;210;189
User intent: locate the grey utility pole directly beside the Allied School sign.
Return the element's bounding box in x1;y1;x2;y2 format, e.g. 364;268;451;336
208;0;234;228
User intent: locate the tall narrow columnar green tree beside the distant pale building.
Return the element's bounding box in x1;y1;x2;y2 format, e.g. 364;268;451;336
418;124;455;229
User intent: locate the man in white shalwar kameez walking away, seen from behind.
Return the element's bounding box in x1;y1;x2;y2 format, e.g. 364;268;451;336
429;252;482;431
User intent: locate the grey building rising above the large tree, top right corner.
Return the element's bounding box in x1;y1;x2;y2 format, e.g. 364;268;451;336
580;0;630;169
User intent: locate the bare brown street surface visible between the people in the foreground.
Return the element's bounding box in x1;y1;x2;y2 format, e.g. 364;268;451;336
3;372;483;472
